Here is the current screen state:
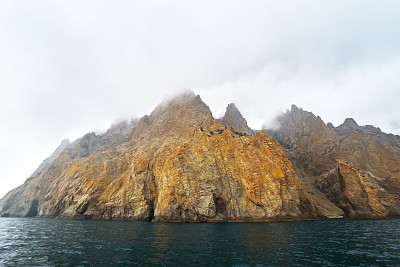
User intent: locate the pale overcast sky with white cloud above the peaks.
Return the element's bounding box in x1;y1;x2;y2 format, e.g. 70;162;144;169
0;0;400;197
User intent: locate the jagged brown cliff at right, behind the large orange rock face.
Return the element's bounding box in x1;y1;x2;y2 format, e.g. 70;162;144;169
267;106;400;218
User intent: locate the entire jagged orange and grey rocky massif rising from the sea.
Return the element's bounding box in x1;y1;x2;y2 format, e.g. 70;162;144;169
0;91;400;222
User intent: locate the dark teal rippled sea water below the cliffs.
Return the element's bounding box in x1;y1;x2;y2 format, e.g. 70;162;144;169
0;218;400;266
